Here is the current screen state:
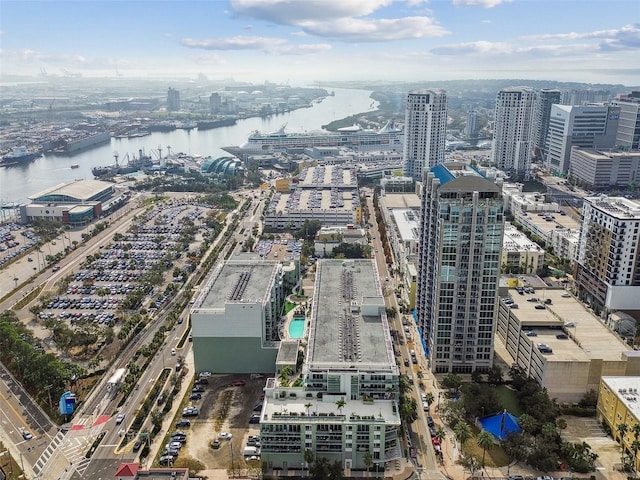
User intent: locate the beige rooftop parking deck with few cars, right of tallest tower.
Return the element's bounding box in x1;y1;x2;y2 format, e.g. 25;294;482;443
502;289;630;361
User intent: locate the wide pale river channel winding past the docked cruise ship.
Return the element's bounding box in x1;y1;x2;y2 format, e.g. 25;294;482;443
0;88;377;203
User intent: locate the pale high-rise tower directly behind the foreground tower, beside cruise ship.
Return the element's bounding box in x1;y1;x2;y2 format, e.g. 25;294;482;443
404;90;447;181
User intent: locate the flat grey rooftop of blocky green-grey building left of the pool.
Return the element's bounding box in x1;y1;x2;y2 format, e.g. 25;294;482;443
196;259;280;309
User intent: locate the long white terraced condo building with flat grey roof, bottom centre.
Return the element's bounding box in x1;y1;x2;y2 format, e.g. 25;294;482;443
260;260;402;476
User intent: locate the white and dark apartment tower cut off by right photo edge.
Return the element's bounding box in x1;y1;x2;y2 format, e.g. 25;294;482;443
576;197;640;318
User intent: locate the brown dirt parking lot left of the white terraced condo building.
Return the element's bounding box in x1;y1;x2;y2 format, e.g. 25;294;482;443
158;375;265;470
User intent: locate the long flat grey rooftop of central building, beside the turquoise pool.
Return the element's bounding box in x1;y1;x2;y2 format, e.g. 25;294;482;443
307;260;397;369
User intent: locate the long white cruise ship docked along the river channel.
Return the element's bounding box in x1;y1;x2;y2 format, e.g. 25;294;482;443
222;120;404;158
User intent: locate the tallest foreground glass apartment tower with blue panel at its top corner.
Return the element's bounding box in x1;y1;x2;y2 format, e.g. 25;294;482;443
417;163;504;373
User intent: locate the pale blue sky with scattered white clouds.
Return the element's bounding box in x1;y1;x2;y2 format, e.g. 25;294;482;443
0;0;640;85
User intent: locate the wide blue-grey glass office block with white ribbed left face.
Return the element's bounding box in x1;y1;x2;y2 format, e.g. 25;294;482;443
545;105;620;173
